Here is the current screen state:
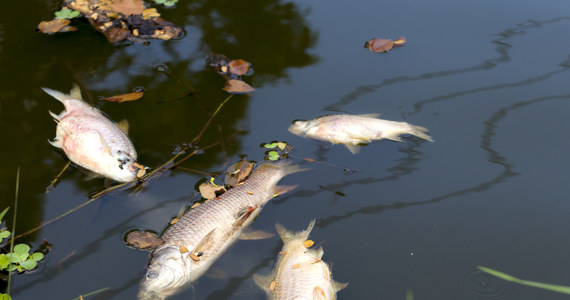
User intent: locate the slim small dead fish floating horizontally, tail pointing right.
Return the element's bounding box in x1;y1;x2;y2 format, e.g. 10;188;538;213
289;114;433;154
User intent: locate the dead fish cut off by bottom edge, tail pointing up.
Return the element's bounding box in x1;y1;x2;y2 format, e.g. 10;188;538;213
253;220;348;300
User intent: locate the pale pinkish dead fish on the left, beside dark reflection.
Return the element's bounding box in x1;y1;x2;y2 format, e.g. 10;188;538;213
42;85;144;182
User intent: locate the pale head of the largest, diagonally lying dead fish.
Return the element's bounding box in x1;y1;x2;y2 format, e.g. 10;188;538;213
138;246;188;300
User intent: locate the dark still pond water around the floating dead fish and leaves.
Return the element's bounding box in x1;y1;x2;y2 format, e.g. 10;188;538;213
0;0;570;300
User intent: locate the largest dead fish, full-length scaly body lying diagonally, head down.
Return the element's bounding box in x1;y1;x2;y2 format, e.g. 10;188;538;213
138;162;303;300
